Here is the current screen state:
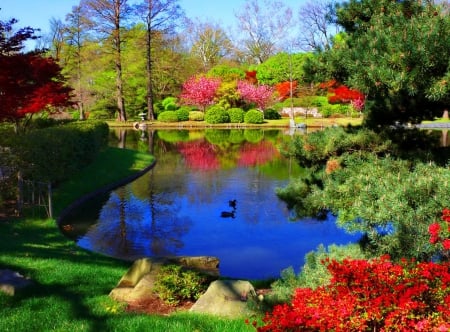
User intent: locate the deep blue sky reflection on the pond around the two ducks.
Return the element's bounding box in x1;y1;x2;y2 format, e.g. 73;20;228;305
65;132;357;278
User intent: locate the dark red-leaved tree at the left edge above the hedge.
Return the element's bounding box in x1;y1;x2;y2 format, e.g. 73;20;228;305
0;16;71;126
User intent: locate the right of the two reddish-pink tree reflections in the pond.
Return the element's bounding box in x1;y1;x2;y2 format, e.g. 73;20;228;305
238;141;279;166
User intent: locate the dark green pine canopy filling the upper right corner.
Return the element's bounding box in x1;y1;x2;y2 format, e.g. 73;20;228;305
306;0;450;125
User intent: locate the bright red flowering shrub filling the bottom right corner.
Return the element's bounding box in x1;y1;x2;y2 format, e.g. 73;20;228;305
253;256;450;332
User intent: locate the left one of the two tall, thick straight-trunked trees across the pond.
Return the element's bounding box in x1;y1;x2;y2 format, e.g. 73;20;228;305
80;0;130;121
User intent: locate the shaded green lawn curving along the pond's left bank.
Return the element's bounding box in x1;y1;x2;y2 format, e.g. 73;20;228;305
0;148;253;332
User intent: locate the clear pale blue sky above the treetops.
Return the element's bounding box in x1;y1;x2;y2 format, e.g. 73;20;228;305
0;0;306;33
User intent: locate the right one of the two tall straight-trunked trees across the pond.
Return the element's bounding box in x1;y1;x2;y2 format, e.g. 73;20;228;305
135;0;184;120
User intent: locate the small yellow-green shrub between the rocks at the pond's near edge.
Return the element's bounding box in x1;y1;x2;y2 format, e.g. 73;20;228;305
154;265;208;305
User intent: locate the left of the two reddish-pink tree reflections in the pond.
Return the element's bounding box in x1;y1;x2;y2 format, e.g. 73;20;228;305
177;141;220;170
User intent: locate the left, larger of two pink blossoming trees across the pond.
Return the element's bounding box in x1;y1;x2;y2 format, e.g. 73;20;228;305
180;76;221;111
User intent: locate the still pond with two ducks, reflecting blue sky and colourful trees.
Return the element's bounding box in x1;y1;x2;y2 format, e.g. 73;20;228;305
60;129;358;279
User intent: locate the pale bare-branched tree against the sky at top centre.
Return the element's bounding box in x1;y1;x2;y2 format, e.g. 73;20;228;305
235;0;292;64
